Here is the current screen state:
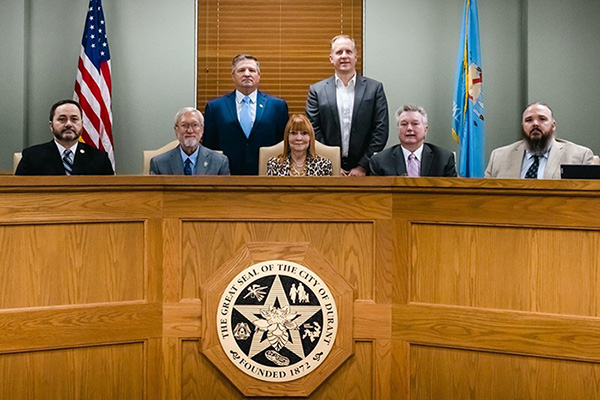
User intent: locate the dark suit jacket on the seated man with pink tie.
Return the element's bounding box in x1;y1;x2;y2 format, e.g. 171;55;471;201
370;143;456;176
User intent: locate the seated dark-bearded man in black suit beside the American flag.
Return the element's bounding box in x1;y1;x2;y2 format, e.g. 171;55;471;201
15;100;114;175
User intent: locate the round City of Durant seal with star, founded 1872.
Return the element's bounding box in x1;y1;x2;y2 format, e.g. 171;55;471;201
217;260;338;382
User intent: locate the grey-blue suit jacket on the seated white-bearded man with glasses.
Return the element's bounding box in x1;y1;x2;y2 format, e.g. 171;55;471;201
150;146;229;175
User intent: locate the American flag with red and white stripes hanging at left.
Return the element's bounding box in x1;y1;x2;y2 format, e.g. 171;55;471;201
73;0;115;169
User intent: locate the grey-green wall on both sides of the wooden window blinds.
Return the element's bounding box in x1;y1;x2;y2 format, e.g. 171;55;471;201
0;0;600;174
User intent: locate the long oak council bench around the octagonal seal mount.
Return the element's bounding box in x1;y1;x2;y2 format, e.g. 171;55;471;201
0;176;600;400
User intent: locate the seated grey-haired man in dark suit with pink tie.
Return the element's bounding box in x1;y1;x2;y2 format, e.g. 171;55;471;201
370;105;456;177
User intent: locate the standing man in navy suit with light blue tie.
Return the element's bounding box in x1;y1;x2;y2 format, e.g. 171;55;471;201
203;54;289;175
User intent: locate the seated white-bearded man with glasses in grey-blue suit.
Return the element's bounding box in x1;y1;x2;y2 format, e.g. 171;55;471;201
150;107;229;175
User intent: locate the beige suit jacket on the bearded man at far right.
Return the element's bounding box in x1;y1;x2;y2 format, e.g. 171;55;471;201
485;139;594;179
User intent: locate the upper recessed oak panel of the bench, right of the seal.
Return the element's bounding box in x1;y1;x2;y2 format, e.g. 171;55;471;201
411;224;600;317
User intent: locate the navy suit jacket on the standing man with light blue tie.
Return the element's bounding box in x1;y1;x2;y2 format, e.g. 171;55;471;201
202;91;289;175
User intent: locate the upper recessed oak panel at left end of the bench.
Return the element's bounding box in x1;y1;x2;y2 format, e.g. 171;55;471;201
0;222;145;309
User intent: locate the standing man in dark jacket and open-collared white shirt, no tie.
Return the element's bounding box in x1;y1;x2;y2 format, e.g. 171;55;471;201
306;35;389;176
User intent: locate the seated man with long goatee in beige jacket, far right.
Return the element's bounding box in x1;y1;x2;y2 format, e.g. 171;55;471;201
485;103;594;179
